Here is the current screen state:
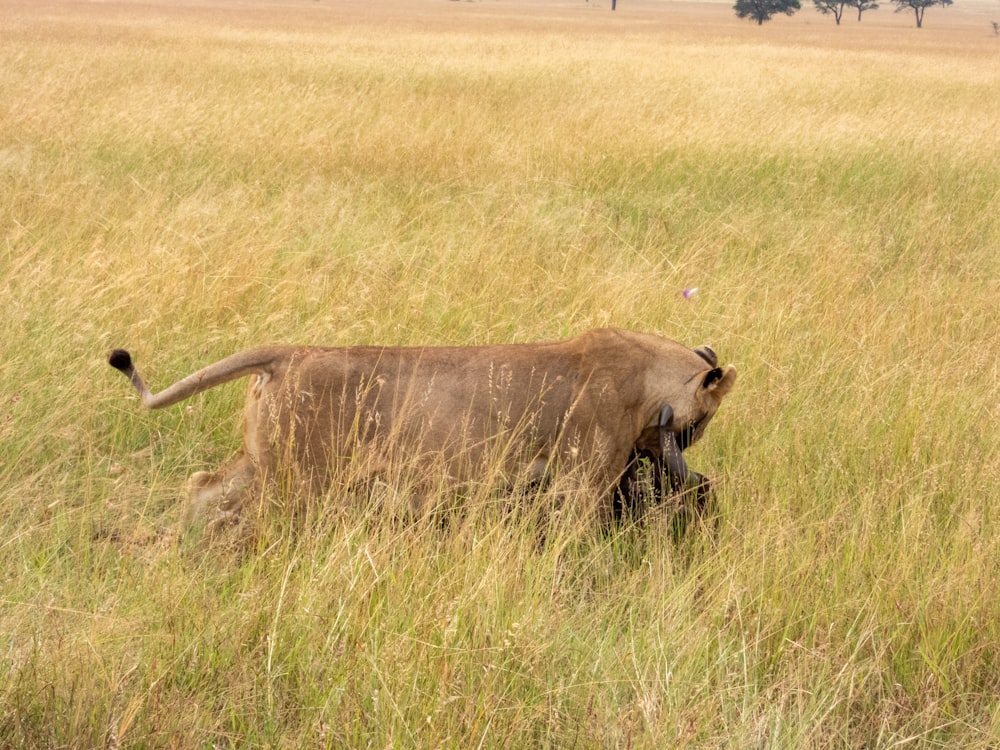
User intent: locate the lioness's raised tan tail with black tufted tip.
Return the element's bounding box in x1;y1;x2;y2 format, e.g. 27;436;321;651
108;347;288;409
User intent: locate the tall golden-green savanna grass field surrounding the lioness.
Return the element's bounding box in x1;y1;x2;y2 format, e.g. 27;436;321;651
0;0;1000;749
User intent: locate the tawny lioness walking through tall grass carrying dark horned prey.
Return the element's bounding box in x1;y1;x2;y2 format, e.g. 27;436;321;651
108;328;736;525
